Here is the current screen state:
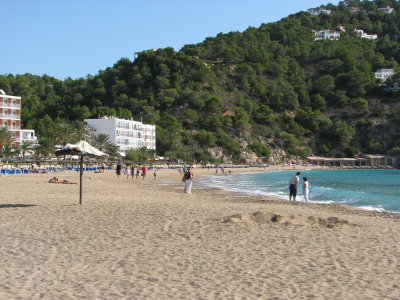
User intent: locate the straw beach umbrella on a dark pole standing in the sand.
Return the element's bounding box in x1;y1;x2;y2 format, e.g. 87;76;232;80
56;141;107;204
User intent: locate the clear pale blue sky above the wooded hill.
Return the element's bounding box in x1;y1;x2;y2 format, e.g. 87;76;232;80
0;0;339;79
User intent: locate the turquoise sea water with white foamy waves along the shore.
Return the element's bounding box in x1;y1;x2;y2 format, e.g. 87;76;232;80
202;169;400;213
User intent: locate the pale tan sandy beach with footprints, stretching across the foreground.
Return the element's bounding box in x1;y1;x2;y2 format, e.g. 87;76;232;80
0;170;400;299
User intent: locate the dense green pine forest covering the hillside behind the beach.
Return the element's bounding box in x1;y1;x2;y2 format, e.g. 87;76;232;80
0;0;400;162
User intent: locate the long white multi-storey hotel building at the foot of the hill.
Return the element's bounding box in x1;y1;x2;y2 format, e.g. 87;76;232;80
85;116;156;154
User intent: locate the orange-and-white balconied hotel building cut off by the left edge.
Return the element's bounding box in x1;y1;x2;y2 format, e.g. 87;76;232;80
0;90;37;146
